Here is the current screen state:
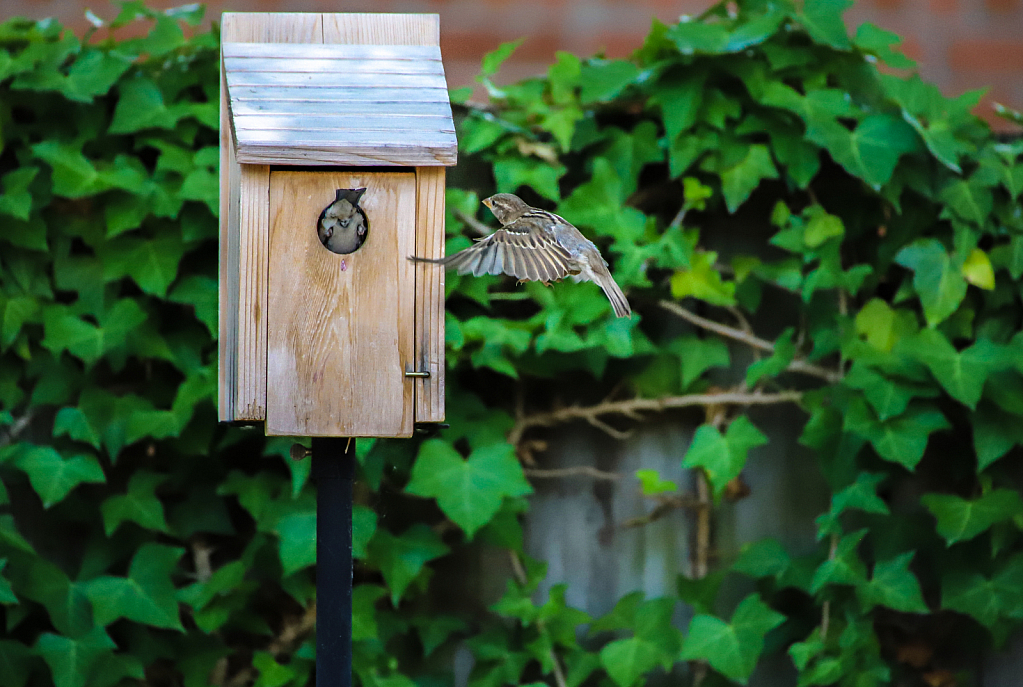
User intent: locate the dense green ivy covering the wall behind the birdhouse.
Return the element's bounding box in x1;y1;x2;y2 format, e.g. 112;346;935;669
0;0;1023;687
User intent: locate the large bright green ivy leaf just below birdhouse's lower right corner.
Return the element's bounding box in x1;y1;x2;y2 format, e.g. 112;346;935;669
405;440;533;539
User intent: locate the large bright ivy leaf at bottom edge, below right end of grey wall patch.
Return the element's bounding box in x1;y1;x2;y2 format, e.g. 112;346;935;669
679;594;785;685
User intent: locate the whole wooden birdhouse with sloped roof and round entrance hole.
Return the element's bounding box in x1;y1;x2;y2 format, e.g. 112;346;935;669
219;13;456;437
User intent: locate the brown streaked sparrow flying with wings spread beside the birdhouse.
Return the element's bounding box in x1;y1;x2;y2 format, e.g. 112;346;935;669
409;193;632;317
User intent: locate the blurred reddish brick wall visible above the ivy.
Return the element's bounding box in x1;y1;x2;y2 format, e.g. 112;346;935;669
7;0;1023;130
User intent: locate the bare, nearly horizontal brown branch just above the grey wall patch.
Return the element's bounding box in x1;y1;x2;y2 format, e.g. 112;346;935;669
508;391;802;446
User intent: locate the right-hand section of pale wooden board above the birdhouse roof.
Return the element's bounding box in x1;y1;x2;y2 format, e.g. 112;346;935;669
323;13;441;45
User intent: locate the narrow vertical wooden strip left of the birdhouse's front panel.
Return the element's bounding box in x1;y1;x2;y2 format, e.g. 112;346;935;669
234;165;270;420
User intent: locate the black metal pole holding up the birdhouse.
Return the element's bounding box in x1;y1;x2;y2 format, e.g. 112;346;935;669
312;437;355;687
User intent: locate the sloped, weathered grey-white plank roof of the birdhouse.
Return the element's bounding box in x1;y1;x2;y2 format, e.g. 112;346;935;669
223;43;457;167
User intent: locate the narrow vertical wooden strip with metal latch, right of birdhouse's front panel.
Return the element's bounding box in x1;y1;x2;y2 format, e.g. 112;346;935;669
415;167;445;422
